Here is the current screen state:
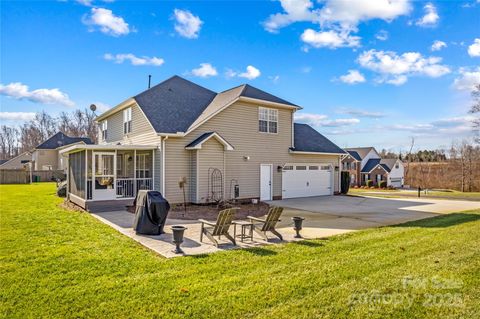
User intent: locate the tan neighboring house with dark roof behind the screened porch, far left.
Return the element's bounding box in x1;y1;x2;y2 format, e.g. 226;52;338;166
32;132;93;171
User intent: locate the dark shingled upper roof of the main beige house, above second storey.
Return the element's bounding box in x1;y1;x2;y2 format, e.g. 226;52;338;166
97;75;300;134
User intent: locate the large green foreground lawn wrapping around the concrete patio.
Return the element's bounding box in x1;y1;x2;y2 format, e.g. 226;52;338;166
0;184;480;318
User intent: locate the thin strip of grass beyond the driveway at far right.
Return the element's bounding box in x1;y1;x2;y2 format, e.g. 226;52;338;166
348;188;480;200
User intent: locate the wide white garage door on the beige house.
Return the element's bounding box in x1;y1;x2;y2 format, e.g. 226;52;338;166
282;164;333;198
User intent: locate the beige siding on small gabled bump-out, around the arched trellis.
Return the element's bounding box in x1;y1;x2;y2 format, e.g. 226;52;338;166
197;138;225;203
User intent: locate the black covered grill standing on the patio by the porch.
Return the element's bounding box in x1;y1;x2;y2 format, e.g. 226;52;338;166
133;190;170;235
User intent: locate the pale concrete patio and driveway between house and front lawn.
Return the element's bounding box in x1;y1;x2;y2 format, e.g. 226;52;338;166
92;196;480;258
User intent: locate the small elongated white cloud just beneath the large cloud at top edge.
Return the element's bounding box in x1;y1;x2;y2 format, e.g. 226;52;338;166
300;29;361;49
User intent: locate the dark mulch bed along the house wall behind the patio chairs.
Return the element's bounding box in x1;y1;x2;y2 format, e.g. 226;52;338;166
127;201;269;221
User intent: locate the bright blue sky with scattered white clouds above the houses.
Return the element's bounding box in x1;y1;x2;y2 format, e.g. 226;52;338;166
0;0;480;151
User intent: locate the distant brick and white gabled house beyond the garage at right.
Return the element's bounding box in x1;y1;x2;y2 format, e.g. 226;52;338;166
342;147;404;187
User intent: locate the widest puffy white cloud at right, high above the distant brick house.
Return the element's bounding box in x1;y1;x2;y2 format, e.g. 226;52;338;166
357;49;451;85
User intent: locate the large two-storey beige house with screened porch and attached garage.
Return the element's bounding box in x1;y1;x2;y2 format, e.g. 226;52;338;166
61;76;344;209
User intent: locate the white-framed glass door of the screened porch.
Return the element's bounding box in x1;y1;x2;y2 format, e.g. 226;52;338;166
92;152;116;200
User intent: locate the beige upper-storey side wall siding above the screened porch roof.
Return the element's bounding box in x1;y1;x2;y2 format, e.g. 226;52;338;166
98;104;160;145
